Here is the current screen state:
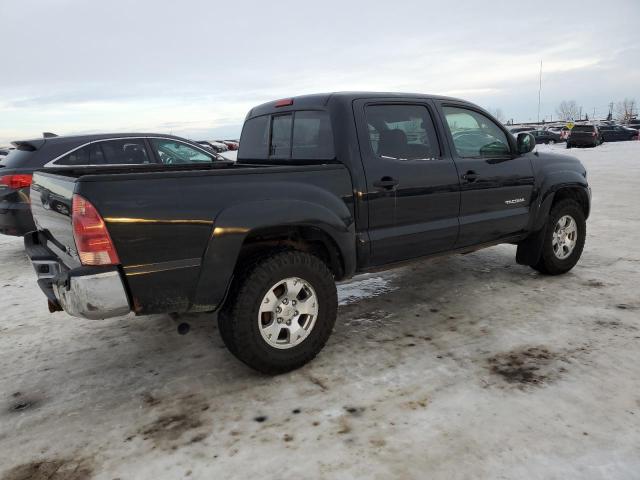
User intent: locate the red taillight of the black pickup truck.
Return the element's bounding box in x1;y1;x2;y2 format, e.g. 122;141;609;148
71;195;120;265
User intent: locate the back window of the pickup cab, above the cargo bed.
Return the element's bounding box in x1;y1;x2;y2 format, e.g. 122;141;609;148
238;110;335;160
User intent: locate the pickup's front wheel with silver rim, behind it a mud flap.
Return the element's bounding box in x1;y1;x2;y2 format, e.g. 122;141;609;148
533;199;587;275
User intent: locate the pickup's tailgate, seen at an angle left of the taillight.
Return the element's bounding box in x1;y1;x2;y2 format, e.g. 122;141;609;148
31;172;78;263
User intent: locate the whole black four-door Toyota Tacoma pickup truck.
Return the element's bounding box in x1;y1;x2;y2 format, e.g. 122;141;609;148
25;93;591;373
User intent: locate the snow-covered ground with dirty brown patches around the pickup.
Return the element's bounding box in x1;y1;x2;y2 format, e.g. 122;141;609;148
0;142;640;480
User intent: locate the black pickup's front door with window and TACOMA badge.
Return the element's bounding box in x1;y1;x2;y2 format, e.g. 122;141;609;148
439;103;534;247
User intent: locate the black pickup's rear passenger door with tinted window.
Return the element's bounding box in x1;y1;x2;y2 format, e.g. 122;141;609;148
354;99;460;265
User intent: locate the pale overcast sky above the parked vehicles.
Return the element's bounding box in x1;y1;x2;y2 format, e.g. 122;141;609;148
0;0;640;144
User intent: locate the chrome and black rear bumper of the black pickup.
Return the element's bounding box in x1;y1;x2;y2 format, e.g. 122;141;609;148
24;232;131;320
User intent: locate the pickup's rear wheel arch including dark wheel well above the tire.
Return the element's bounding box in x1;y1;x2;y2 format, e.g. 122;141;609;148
191;199;356;311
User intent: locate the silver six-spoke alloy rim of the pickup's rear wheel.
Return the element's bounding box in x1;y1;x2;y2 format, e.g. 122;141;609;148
258;277;318;349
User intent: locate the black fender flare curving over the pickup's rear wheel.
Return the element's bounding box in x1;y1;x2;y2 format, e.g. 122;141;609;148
190;197;356;311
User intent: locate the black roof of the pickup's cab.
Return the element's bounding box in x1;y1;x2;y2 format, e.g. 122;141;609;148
247;92;461;118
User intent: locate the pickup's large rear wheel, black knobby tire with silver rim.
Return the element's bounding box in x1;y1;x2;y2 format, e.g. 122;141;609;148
218;251;338;374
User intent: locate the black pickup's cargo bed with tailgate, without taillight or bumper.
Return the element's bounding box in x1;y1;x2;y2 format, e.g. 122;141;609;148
31;159;354;314
